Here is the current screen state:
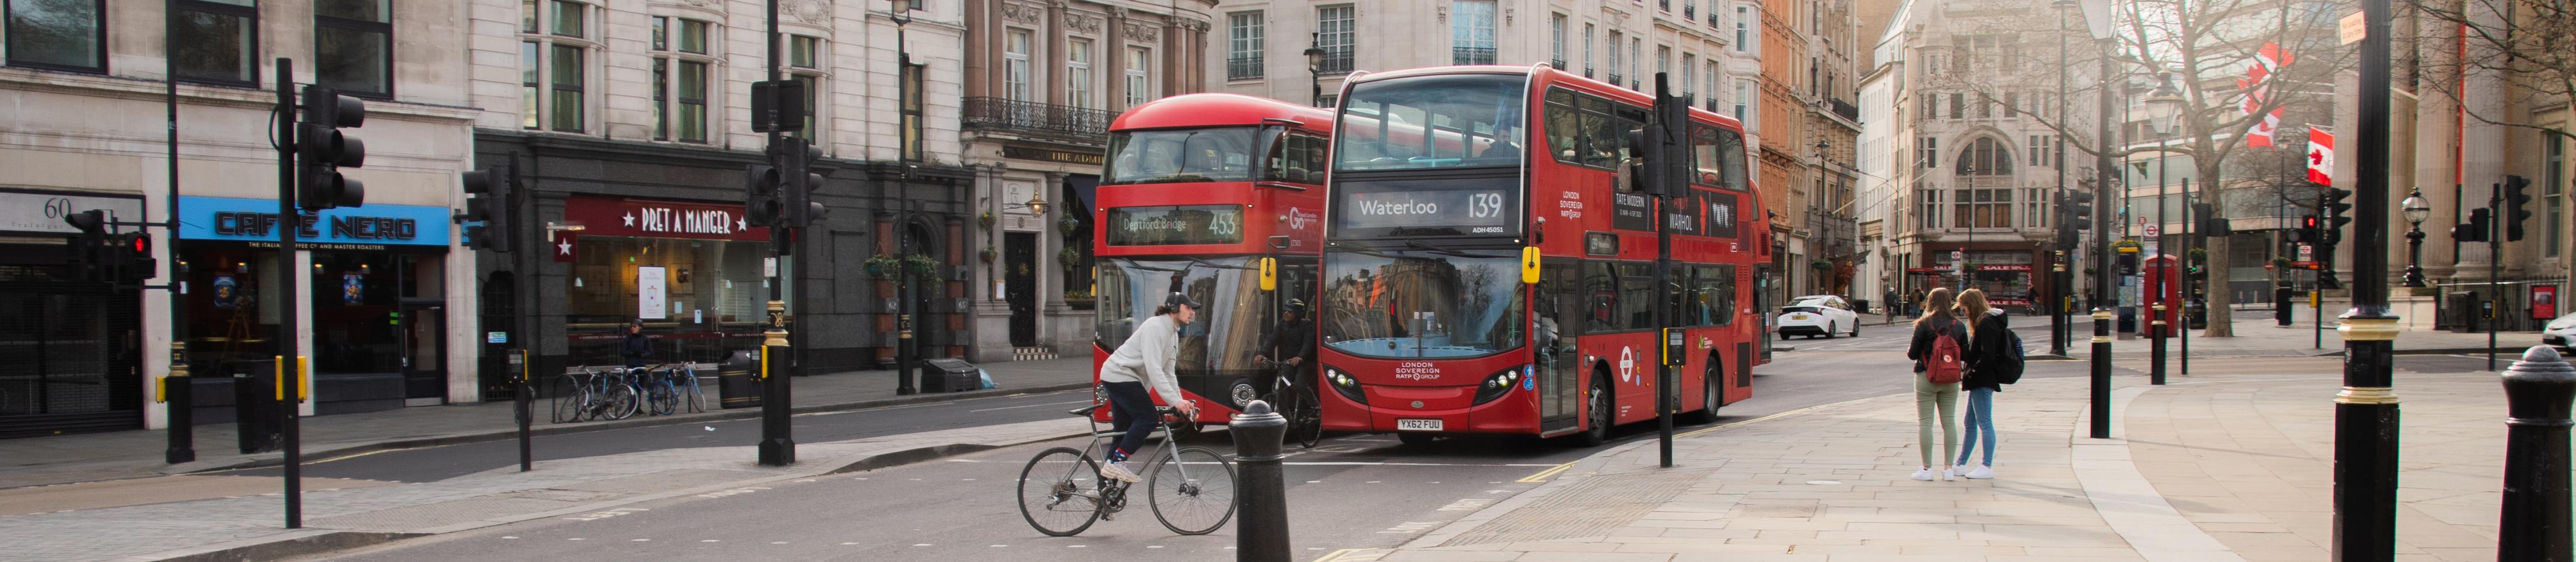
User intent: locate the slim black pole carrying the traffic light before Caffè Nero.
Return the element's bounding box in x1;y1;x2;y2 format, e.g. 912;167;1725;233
268;57;309;528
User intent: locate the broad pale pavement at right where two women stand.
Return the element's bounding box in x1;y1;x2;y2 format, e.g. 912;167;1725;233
1326;358;2504;562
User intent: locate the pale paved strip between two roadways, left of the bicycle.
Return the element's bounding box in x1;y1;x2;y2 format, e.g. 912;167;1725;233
0;420;1087;562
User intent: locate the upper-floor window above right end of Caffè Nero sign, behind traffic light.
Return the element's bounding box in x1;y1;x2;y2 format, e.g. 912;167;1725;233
314;0;394;98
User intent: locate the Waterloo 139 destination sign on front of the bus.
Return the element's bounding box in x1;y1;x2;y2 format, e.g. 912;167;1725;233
1332;183;1520;235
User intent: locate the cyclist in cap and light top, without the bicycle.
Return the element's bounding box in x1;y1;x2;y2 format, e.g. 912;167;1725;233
1100;292;1198;482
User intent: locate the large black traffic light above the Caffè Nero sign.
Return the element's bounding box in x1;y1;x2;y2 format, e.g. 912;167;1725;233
296;85;366;212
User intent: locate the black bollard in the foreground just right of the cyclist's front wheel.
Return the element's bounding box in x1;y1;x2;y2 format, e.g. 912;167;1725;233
1226;400;1288;562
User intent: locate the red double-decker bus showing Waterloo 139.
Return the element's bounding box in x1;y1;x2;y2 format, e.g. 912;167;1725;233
1319;64;1770;443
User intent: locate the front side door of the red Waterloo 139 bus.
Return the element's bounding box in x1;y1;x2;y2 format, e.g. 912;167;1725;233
1530;263;1584;433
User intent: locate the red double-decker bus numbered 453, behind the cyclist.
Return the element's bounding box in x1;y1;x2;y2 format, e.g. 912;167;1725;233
1092;93;1332;430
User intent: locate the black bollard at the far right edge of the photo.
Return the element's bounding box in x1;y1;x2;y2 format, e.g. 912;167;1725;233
2496;345;2576;562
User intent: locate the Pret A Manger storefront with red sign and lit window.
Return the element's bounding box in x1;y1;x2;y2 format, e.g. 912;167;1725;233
546;196;767;366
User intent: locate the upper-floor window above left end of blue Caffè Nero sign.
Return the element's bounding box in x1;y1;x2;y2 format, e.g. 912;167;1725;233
171;0;260;87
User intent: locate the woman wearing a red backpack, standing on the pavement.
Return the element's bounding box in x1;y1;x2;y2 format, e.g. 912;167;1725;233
1907;286;1968;480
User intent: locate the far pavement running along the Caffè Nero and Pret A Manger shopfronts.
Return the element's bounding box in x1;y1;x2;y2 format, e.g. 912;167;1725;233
0;353;1092;490
